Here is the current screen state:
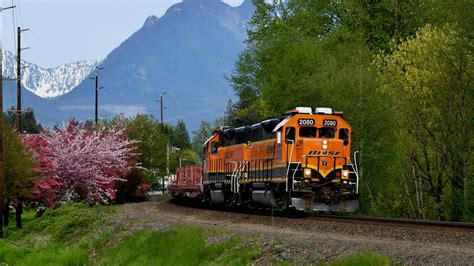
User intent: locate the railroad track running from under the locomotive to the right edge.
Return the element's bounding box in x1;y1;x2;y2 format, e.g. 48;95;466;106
305;214;474;231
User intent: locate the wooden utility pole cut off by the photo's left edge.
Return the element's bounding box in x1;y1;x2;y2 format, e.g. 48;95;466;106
0;3;15;238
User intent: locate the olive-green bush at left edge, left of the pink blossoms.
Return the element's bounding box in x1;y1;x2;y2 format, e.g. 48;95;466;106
4;125;35;198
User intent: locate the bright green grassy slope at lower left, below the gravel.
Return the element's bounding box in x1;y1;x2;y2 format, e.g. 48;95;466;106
0;203;261;265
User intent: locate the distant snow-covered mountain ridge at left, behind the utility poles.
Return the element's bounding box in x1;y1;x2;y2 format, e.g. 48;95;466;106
2;50;100;98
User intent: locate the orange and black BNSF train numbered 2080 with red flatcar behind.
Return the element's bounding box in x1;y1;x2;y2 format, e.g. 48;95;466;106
169;107;359;212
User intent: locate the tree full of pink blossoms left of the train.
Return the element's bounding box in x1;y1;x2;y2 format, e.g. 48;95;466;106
23;120;135;205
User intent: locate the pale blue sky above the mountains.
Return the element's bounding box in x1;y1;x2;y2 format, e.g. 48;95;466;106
0;0;243;67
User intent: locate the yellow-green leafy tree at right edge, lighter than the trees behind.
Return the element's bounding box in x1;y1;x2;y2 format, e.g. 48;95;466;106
374;25;474;220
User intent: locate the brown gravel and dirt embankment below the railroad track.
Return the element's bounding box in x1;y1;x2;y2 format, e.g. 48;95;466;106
112;201;474;265
